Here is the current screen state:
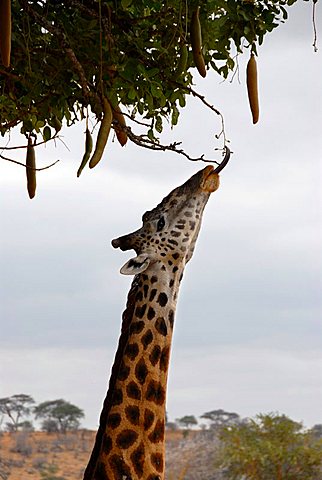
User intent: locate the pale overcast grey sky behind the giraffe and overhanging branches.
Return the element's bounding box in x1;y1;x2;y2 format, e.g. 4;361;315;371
0;2;322;429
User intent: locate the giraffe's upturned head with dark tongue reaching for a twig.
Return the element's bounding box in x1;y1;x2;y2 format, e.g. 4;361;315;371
112;149;229;275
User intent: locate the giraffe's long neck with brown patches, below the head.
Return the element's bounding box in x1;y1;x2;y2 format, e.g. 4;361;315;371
84;264;183;480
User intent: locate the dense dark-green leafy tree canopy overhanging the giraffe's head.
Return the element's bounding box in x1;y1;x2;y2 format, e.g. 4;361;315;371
0;0;316;195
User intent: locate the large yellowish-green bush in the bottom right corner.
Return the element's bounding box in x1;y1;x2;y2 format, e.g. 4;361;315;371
221;414;322;480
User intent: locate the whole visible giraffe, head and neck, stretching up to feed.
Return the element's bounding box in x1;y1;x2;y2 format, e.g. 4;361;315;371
84;148;230;480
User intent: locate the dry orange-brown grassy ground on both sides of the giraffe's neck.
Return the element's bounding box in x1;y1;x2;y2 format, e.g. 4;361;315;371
0;430;219;480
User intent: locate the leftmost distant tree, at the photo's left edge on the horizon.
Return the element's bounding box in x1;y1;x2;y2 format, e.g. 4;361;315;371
0;393;35;432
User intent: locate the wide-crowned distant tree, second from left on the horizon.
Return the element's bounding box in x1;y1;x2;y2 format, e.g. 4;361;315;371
34;399;84;433
